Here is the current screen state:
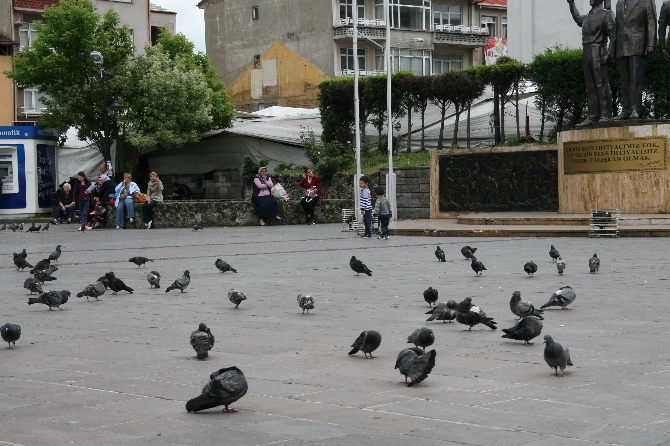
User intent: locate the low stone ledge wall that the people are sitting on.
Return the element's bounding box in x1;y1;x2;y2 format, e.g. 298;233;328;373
108;199;354;228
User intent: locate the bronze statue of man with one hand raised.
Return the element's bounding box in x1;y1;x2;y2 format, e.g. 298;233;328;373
568;0;616;127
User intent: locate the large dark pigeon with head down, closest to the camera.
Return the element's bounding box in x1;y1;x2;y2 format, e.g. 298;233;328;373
186;367;249;413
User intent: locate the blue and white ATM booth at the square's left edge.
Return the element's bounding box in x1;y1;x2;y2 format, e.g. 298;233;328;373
0;126;58;215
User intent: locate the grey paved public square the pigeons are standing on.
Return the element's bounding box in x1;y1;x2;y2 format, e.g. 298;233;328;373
0;224;670;446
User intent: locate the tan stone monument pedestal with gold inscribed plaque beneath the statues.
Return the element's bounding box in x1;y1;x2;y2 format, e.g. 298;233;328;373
558;121;670;214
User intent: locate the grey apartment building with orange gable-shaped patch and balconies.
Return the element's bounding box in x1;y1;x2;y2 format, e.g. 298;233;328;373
198;0;507;111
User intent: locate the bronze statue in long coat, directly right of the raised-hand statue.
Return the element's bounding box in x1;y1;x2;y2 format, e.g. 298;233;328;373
612;0;656;119
